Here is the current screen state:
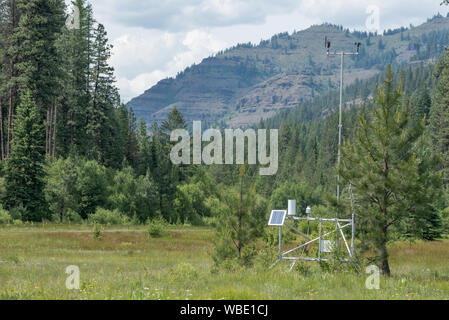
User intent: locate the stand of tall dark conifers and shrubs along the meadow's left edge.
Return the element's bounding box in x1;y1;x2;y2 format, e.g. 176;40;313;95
0;0;195;221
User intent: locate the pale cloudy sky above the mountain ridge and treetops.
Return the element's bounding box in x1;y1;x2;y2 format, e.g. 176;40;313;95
79;0;449;102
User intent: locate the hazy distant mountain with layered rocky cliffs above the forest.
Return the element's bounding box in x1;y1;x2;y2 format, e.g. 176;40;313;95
128;16;449;127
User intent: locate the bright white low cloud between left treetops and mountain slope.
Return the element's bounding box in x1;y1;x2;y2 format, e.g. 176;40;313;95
111;29;227;101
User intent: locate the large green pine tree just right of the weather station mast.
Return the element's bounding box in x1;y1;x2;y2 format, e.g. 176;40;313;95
340;66;441;275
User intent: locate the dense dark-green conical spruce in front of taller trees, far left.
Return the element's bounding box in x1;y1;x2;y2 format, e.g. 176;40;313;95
3;90;48;221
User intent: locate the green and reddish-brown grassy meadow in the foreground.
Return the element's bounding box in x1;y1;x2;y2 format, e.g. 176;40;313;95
0;226;449;300
